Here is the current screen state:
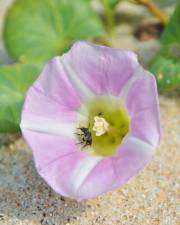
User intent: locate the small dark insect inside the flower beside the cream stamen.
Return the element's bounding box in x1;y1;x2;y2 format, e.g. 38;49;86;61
77;127;92;149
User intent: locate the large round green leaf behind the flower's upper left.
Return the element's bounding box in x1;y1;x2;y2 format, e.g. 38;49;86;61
4;0;103;62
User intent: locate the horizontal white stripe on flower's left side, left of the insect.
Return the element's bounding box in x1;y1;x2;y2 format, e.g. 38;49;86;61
20;116;75;137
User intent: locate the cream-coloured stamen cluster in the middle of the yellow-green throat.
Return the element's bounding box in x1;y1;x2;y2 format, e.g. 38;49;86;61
93;116;109;136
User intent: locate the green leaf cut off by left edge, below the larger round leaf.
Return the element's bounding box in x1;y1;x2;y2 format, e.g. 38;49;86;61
0;64;40;132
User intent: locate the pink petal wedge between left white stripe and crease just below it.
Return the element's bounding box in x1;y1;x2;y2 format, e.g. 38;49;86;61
23;129;78;172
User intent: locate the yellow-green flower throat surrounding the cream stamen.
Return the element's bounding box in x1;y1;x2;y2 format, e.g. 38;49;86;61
78;97;130;156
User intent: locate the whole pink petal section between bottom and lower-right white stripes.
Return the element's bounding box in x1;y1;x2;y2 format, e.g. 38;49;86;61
71;134;154;200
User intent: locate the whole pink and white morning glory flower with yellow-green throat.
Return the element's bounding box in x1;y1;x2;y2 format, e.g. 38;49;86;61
21;42;160;200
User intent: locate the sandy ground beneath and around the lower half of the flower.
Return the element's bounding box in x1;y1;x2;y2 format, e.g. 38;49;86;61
0;96;180;225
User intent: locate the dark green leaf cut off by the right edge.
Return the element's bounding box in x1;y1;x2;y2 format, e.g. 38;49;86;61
150;4;180;91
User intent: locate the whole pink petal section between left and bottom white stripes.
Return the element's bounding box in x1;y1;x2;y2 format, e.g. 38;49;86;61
23;129;81;198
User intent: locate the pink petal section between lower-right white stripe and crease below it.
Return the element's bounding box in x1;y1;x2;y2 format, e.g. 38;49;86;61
112;136;154;189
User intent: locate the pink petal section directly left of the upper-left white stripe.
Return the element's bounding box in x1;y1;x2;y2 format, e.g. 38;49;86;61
33;57;80;110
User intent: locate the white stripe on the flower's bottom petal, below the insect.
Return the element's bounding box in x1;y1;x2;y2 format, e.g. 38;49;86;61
71;156;103;196
